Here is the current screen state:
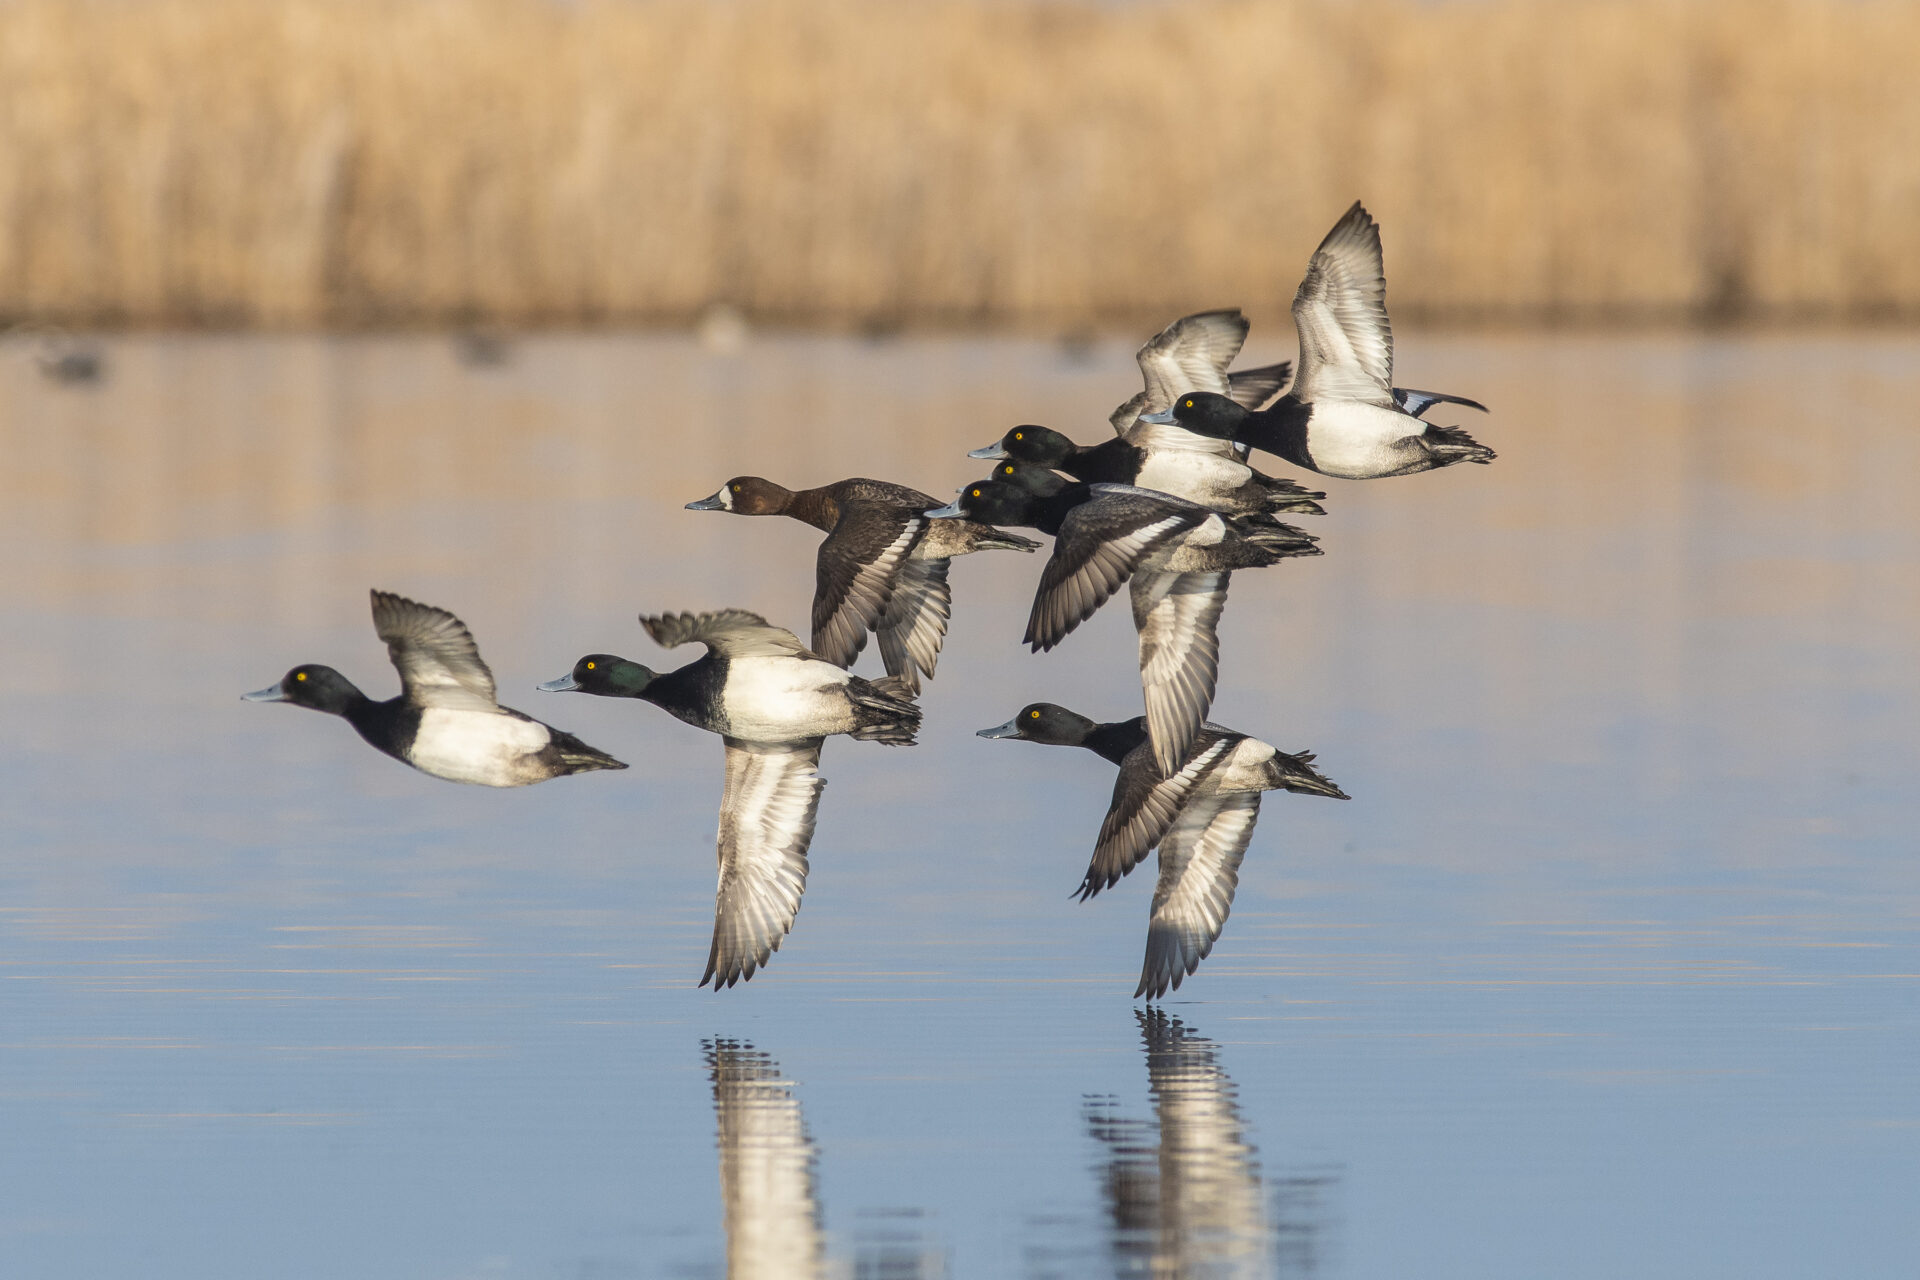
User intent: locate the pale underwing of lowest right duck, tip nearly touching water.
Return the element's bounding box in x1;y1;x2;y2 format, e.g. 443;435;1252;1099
1133;791;1260;998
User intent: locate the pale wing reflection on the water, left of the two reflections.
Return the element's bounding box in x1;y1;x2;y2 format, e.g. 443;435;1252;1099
705;1040;826;1280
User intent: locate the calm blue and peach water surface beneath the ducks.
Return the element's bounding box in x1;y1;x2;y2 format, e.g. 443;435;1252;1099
0;330;1920;1280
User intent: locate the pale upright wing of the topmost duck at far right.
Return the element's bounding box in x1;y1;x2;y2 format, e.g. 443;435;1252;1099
1294;200;1394;407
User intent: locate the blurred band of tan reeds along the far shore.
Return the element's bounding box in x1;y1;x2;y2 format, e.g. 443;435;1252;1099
0;0;1920;326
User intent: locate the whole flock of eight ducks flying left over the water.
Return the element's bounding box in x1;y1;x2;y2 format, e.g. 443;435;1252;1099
246;201;1494;998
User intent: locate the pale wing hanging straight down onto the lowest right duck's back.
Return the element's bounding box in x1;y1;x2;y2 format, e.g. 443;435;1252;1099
1133;572;1233;773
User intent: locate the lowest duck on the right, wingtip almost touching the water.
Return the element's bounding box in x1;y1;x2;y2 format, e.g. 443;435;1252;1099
979;702;1346;1000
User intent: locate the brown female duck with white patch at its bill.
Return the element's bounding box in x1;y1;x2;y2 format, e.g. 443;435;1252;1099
687;476;1039;693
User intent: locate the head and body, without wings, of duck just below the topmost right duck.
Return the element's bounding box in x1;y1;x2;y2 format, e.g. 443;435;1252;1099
968;424;1327;516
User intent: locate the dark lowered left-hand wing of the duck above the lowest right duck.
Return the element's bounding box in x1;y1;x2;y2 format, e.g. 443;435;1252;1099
1025;498;1210;651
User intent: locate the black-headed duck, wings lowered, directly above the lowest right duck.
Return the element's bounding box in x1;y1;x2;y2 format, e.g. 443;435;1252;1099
927;480;1319;773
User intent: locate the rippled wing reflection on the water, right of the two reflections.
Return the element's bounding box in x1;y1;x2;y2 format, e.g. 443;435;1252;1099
1085;1009;1275;1280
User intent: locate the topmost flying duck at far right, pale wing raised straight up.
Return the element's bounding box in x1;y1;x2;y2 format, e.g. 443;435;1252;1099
1140;200;1494;480
